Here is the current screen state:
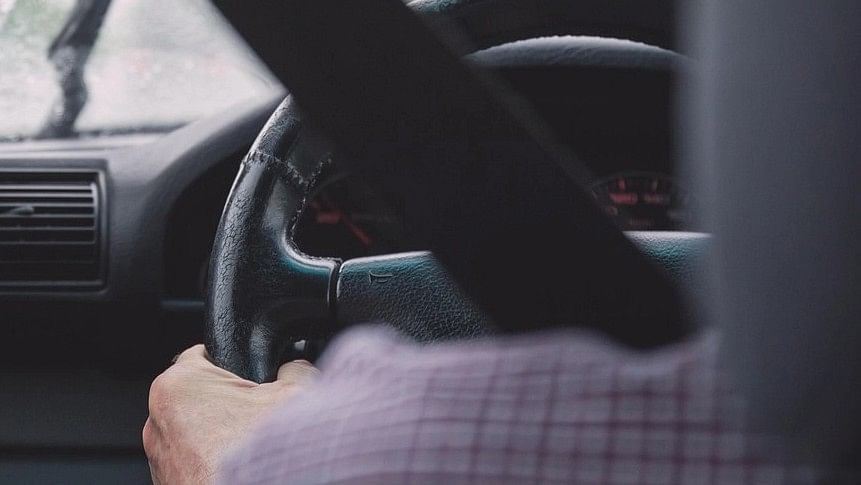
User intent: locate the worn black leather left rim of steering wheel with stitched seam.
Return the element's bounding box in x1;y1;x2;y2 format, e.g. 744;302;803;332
206;99;339;382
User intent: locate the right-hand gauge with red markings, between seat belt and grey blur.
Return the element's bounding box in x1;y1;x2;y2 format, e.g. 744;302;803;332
592;172;691;231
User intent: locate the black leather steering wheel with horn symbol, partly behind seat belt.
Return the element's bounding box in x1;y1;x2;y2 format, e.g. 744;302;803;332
206;2;706;382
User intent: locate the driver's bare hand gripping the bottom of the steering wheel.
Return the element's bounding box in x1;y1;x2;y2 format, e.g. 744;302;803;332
143;345;318;485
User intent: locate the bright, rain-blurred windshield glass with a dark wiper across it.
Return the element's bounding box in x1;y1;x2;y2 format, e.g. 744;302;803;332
0;0;278;142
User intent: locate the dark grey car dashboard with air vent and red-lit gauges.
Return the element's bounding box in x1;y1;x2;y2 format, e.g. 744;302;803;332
0;47;684;478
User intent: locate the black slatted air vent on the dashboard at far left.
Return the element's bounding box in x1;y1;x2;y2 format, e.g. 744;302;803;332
0;171;103;290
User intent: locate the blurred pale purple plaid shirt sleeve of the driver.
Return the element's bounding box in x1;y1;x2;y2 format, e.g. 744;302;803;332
221;327;814;485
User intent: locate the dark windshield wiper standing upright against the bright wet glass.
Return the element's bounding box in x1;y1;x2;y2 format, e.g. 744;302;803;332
35;0;111;139
